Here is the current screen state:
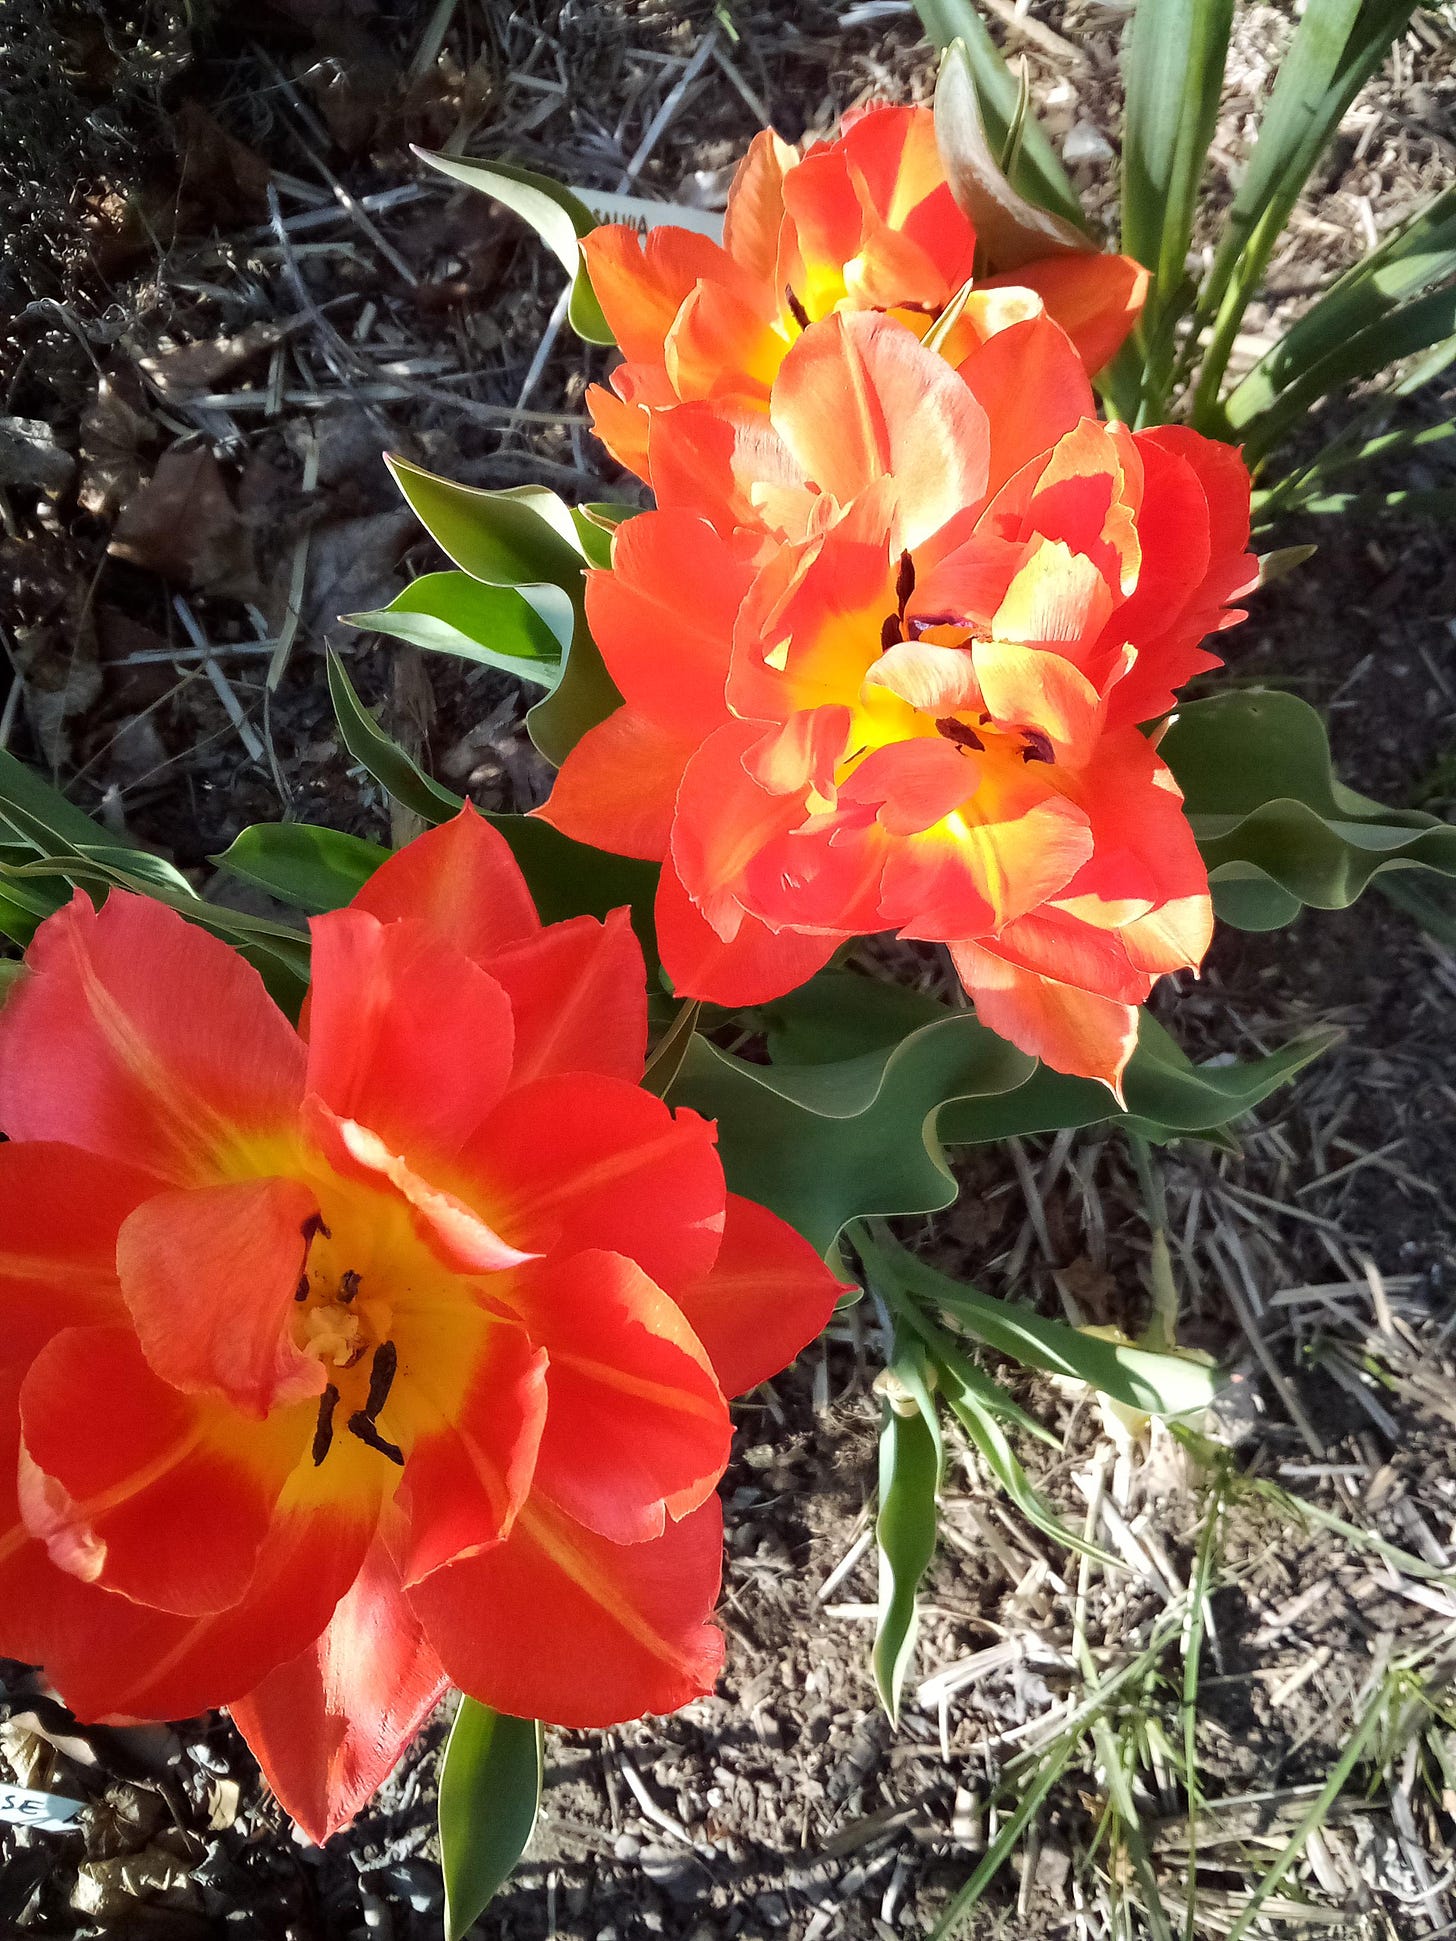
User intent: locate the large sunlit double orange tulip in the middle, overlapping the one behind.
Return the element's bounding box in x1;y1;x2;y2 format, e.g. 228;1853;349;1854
540;314;1254;1095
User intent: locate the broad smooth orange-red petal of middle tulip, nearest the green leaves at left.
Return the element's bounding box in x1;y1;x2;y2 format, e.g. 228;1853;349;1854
586;510;753;741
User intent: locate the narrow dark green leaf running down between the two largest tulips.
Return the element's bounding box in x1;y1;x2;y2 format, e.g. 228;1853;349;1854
328;652;658;969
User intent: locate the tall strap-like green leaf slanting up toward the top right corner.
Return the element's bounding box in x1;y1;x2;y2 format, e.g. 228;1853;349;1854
1194;0;1415;431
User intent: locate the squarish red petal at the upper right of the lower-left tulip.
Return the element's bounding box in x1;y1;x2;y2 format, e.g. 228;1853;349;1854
489;910;646;1089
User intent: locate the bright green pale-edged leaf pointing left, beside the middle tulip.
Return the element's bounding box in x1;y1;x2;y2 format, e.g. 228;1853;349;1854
344;573;577;689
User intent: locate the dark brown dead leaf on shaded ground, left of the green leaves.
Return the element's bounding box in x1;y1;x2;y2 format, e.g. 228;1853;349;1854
107;444;262;600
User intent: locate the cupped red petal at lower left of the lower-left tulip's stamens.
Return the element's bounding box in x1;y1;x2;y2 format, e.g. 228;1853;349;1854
19;1326;298;1613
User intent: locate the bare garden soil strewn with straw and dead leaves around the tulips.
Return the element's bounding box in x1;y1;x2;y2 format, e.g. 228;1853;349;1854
0;0;1456;1941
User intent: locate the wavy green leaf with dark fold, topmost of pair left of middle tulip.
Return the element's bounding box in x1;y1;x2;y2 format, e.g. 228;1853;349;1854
388;458;621;765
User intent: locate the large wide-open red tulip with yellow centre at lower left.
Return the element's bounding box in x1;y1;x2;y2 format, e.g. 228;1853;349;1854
0;809;837;1840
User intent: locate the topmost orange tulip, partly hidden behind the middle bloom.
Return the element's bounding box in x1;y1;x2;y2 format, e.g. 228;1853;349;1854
582;107;1147;483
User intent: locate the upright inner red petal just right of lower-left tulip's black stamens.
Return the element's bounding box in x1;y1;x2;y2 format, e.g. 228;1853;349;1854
396;1318;547;1584
